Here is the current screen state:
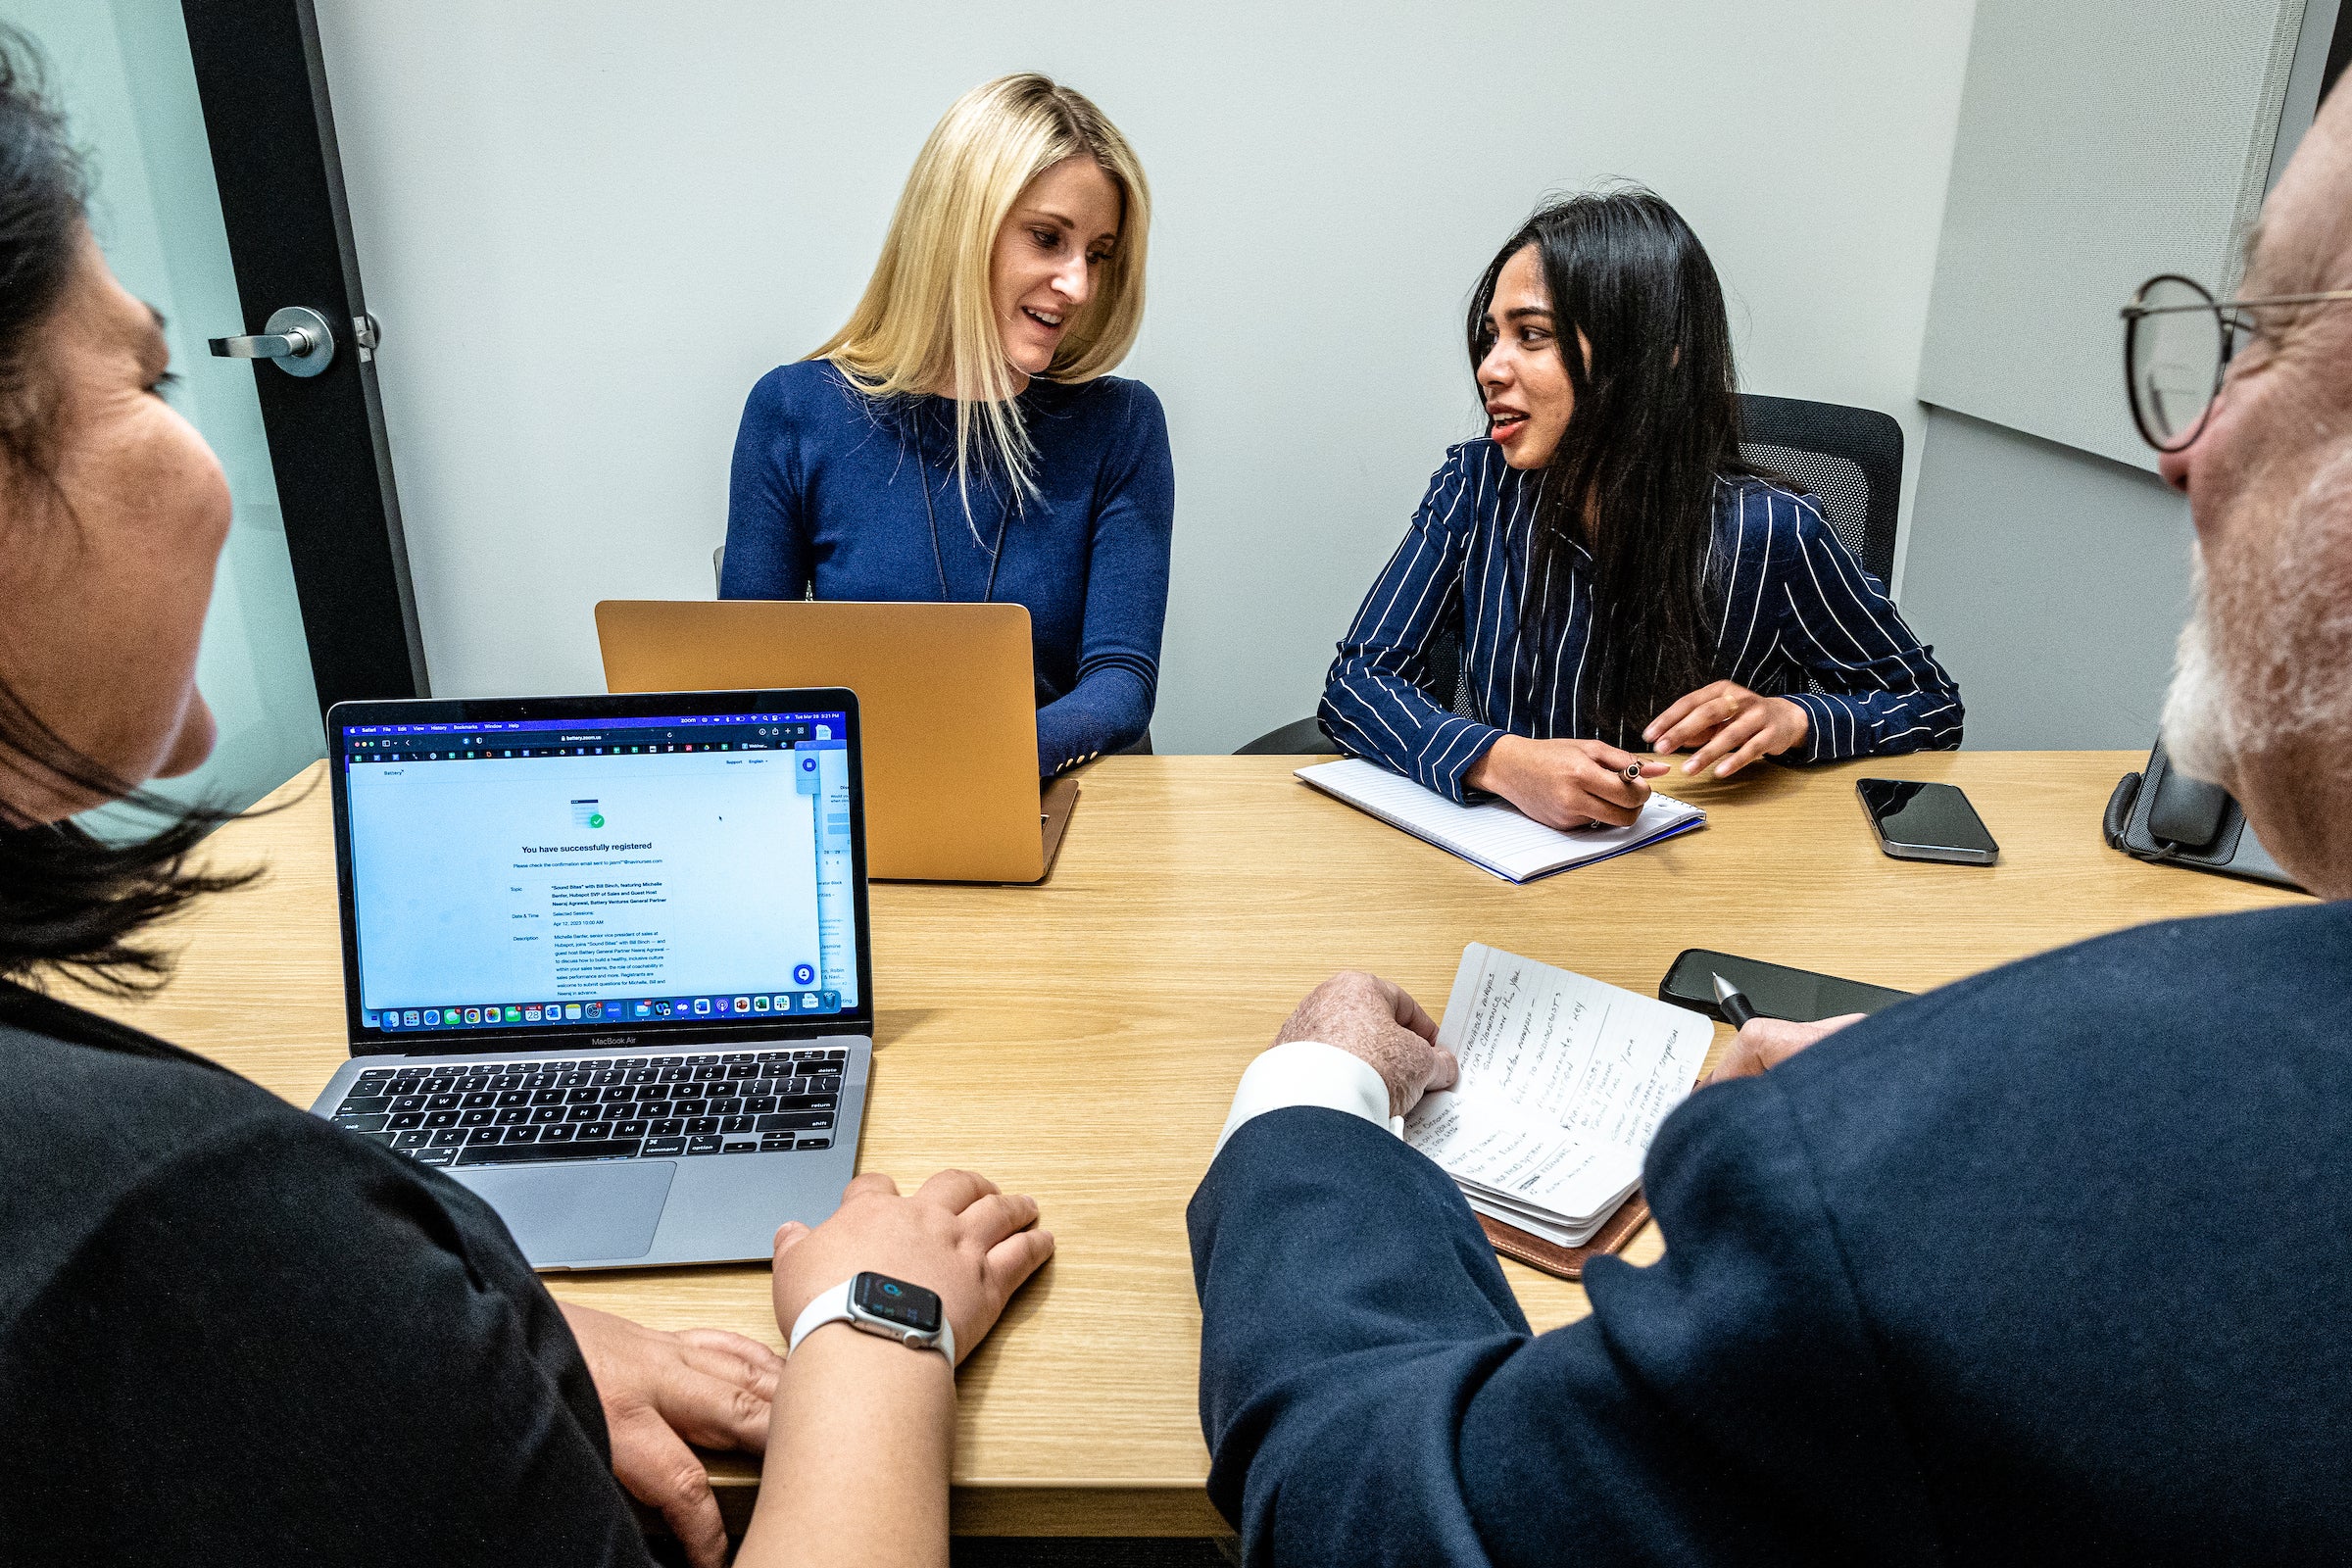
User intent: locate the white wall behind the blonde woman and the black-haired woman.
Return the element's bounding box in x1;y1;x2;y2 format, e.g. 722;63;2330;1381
318;0;1971;750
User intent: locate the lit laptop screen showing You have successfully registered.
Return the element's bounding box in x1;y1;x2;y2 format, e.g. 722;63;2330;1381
331;694;865;1051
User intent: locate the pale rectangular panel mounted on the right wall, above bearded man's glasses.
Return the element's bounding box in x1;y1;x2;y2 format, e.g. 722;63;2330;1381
1919;0;2305;475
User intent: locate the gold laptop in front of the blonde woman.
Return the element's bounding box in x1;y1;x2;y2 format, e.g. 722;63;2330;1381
595;600;1077;882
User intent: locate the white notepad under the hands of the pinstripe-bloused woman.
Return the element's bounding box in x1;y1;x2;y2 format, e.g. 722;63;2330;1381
1298;757;1707;882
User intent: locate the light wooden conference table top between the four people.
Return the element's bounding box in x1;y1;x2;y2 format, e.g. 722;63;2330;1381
86;753;2295;1535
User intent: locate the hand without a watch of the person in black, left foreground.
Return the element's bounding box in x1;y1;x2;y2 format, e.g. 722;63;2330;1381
560;1302;783;1568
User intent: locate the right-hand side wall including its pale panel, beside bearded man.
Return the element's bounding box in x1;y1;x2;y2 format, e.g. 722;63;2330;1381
1903;0;2340;750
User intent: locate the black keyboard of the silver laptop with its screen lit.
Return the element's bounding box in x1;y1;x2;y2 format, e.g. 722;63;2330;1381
334;1049;849;1166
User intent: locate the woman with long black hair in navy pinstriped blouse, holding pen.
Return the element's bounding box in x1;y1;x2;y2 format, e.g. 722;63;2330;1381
1319;190;1962;827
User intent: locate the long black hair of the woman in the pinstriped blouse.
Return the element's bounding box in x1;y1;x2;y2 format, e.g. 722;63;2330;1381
1470;186;1757;745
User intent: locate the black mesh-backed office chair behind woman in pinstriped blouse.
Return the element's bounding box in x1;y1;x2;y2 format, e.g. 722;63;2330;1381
1233;393;1903;757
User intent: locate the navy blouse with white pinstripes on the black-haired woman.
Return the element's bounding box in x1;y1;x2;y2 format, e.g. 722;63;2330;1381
1317;440;1962;800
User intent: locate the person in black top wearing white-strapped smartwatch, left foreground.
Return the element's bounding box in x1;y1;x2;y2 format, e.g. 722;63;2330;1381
0;28;1054;1568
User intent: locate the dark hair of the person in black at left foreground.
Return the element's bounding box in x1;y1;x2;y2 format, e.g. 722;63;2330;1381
0;25;249;992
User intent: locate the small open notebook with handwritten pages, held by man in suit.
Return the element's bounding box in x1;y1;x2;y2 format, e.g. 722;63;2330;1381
1404;943;1715;1279
